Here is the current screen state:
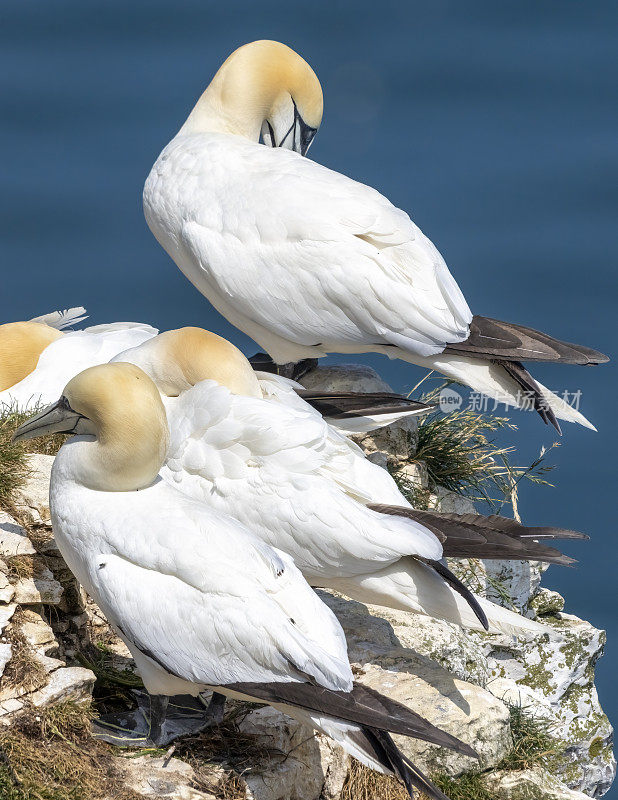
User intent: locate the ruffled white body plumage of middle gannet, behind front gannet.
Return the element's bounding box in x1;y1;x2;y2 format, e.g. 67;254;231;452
161;380;542;633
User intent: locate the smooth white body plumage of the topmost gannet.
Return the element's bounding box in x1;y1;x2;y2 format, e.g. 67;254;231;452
144;133;472;363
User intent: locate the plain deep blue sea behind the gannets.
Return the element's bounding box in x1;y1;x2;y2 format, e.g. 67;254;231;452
0;0;618;788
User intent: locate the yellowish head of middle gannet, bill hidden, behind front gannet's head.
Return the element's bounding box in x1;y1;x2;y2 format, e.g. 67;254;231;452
114;328;262;397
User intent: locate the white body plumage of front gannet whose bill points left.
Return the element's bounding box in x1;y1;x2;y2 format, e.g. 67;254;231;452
50;454;352;695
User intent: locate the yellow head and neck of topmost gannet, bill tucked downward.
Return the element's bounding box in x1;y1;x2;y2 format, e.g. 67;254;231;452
181;40;323;155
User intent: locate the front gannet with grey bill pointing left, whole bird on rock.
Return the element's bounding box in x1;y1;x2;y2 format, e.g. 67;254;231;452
15;363;476;800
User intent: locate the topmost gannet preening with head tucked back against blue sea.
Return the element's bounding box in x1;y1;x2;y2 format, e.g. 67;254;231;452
143;41;607;431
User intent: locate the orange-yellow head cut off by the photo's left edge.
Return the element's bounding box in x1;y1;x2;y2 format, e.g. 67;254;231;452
0;322;63;392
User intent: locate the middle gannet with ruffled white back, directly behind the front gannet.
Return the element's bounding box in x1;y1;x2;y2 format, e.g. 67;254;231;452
116;328;582;633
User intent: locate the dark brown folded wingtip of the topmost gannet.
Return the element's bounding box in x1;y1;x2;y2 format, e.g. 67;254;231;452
444;316;609;365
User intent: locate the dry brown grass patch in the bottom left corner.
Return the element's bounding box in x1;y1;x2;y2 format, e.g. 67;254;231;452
0;703;141;800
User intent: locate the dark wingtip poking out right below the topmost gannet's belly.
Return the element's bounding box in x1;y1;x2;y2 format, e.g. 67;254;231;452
298;390;436;419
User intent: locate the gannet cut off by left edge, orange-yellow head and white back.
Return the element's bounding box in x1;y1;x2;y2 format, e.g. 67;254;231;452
0;308;158;411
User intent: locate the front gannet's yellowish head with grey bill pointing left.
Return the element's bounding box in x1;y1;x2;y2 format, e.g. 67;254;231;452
13;363;169;491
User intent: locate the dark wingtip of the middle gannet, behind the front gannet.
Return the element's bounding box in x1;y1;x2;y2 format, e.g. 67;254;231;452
369;505;589;566
